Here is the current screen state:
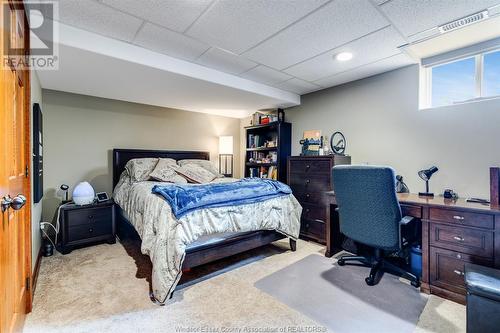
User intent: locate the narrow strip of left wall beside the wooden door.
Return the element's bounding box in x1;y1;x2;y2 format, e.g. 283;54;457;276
30;71;43;270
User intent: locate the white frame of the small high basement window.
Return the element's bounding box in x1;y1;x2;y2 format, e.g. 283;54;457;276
420;47;500;109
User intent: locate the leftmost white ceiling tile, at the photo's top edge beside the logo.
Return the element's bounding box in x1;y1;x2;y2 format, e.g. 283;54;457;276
58;0;143;42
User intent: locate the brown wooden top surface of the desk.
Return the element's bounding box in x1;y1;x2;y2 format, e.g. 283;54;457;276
326;191;500;213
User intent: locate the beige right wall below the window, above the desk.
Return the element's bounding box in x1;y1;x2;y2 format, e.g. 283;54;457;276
286;66;500;198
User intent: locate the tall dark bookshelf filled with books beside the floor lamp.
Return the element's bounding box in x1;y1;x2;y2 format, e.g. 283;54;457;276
245;121;292;182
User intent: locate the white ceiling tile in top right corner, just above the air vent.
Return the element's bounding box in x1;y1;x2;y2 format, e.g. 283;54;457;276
380;0;500;36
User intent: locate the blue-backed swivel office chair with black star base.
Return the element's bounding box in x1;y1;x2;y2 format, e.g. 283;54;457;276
332;165;420;288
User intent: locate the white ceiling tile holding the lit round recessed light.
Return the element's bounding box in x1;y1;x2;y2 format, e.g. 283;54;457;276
285;26;405;81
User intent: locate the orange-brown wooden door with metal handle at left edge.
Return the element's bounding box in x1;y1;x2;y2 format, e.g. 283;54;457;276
0;1;31;333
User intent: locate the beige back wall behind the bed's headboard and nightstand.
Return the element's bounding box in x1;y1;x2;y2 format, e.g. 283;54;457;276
43;90;240;221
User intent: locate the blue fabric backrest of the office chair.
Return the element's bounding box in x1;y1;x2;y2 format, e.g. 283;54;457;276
332;165;401;250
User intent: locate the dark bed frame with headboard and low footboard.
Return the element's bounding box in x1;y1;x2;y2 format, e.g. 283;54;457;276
113;149;297;270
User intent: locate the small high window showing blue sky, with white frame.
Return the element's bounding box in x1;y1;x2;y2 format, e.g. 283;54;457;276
421;50;500;108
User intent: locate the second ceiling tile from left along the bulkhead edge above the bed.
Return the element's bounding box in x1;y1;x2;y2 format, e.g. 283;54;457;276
134;23;209;61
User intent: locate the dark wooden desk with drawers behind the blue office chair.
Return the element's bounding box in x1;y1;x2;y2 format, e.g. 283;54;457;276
325;191;500;304
